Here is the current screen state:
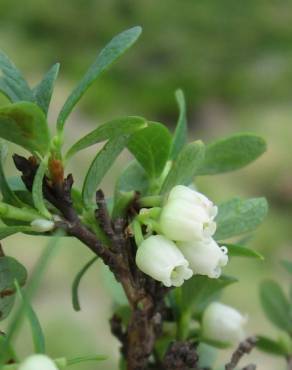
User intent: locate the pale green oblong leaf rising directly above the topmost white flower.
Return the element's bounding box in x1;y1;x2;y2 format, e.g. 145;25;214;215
161;141;205;194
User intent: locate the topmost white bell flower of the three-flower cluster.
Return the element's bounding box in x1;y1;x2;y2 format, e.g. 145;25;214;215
160;185;218;241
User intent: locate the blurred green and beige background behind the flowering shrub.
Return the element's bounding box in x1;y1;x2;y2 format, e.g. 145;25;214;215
0;0;292;370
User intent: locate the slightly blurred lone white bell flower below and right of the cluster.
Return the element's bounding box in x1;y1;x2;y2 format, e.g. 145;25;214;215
202;302;247;344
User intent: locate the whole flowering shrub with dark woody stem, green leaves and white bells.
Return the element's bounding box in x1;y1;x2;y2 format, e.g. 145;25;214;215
0;27;280;370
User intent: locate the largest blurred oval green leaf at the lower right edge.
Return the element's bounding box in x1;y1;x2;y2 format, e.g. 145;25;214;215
260;280;292;334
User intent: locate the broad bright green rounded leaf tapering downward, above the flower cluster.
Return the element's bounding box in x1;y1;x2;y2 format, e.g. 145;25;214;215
128;122;171;178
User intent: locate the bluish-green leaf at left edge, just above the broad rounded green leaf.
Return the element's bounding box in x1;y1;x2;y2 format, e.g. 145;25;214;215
0;50;34;102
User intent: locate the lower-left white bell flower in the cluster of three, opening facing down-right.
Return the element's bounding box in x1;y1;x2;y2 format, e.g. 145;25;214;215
136;235;193;287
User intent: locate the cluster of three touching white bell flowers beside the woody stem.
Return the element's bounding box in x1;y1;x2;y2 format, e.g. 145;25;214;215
136;185;228;287
